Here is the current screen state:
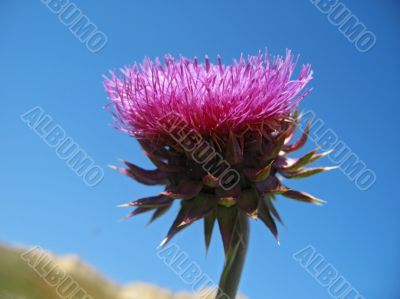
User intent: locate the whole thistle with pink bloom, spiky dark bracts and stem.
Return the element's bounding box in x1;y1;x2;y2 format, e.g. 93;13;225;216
104;51;330;298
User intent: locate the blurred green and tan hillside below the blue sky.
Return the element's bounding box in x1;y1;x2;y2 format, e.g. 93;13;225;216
0;245;245;299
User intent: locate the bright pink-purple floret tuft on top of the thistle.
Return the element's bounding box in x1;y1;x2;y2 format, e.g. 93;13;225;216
104;50;312;139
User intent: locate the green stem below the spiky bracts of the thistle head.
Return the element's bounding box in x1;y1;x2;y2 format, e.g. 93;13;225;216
215;212;249;299
